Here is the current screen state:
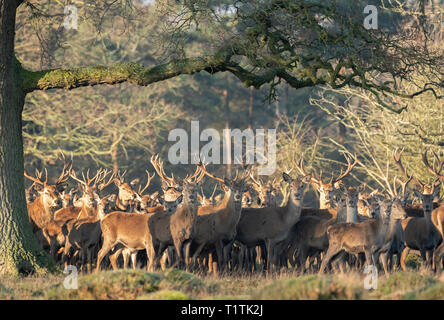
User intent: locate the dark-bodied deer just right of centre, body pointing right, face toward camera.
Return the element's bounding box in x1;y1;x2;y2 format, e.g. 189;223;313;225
236;173;311;270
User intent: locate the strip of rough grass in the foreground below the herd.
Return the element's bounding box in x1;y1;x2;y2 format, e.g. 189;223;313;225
0;269;444;300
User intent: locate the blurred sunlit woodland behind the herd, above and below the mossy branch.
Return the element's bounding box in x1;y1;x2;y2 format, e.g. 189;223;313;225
16;0;444;205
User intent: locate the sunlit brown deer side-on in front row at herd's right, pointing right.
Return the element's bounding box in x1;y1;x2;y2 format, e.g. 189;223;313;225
319;199;407;275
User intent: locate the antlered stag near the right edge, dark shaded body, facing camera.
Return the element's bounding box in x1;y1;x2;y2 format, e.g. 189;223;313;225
393;150;442;270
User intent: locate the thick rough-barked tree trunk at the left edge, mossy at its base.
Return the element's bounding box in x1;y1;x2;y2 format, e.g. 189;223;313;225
0;1;54;275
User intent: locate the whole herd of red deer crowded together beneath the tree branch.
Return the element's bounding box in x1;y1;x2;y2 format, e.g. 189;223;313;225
24;150;444;275
